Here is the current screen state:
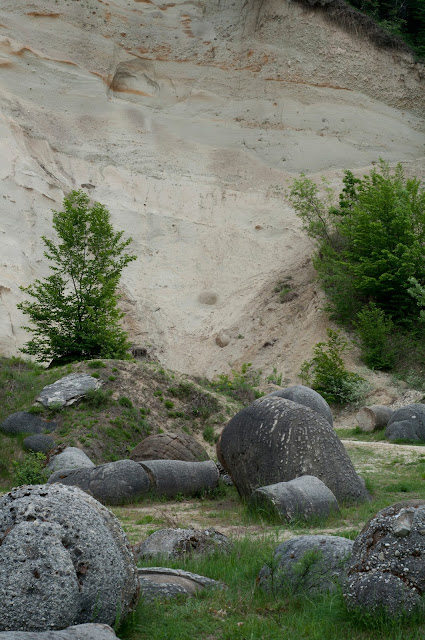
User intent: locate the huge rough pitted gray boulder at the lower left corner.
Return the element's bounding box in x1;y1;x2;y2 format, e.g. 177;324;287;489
0;485;139;631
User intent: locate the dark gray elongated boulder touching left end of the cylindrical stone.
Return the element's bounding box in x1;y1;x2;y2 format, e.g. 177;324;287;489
48;460;149;505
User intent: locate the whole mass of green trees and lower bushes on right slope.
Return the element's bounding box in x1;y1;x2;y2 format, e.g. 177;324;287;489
289;160;425;380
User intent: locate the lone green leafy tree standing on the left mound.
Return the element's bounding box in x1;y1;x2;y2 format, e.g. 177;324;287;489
18;191;136;364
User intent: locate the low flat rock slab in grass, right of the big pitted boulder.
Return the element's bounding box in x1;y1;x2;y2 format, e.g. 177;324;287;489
138;567;225;600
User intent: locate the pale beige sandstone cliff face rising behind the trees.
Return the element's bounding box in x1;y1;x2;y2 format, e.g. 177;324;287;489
0;0;425;379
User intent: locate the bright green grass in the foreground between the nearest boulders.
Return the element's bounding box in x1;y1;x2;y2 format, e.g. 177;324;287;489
118;536;425;640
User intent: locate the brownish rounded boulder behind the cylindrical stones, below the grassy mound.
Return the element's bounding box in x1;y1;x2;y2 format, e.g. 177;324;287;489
130;433;209;462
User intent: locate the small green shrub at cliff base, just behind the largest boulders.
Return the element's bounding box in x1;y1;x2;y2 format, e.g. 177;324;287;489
300;329;367;404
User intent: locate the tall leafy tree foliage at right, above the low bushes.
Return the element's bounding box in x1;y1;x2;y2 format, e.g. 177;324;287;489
290;161;425;324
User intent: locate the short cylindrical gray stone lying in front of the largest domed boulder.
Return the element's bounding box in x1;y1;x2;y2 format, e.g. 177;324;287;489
250;476;339;522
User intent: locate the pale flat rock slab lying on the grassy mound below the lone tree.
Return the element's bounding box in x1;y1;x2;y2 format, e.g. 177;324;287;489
36;373;102;408
